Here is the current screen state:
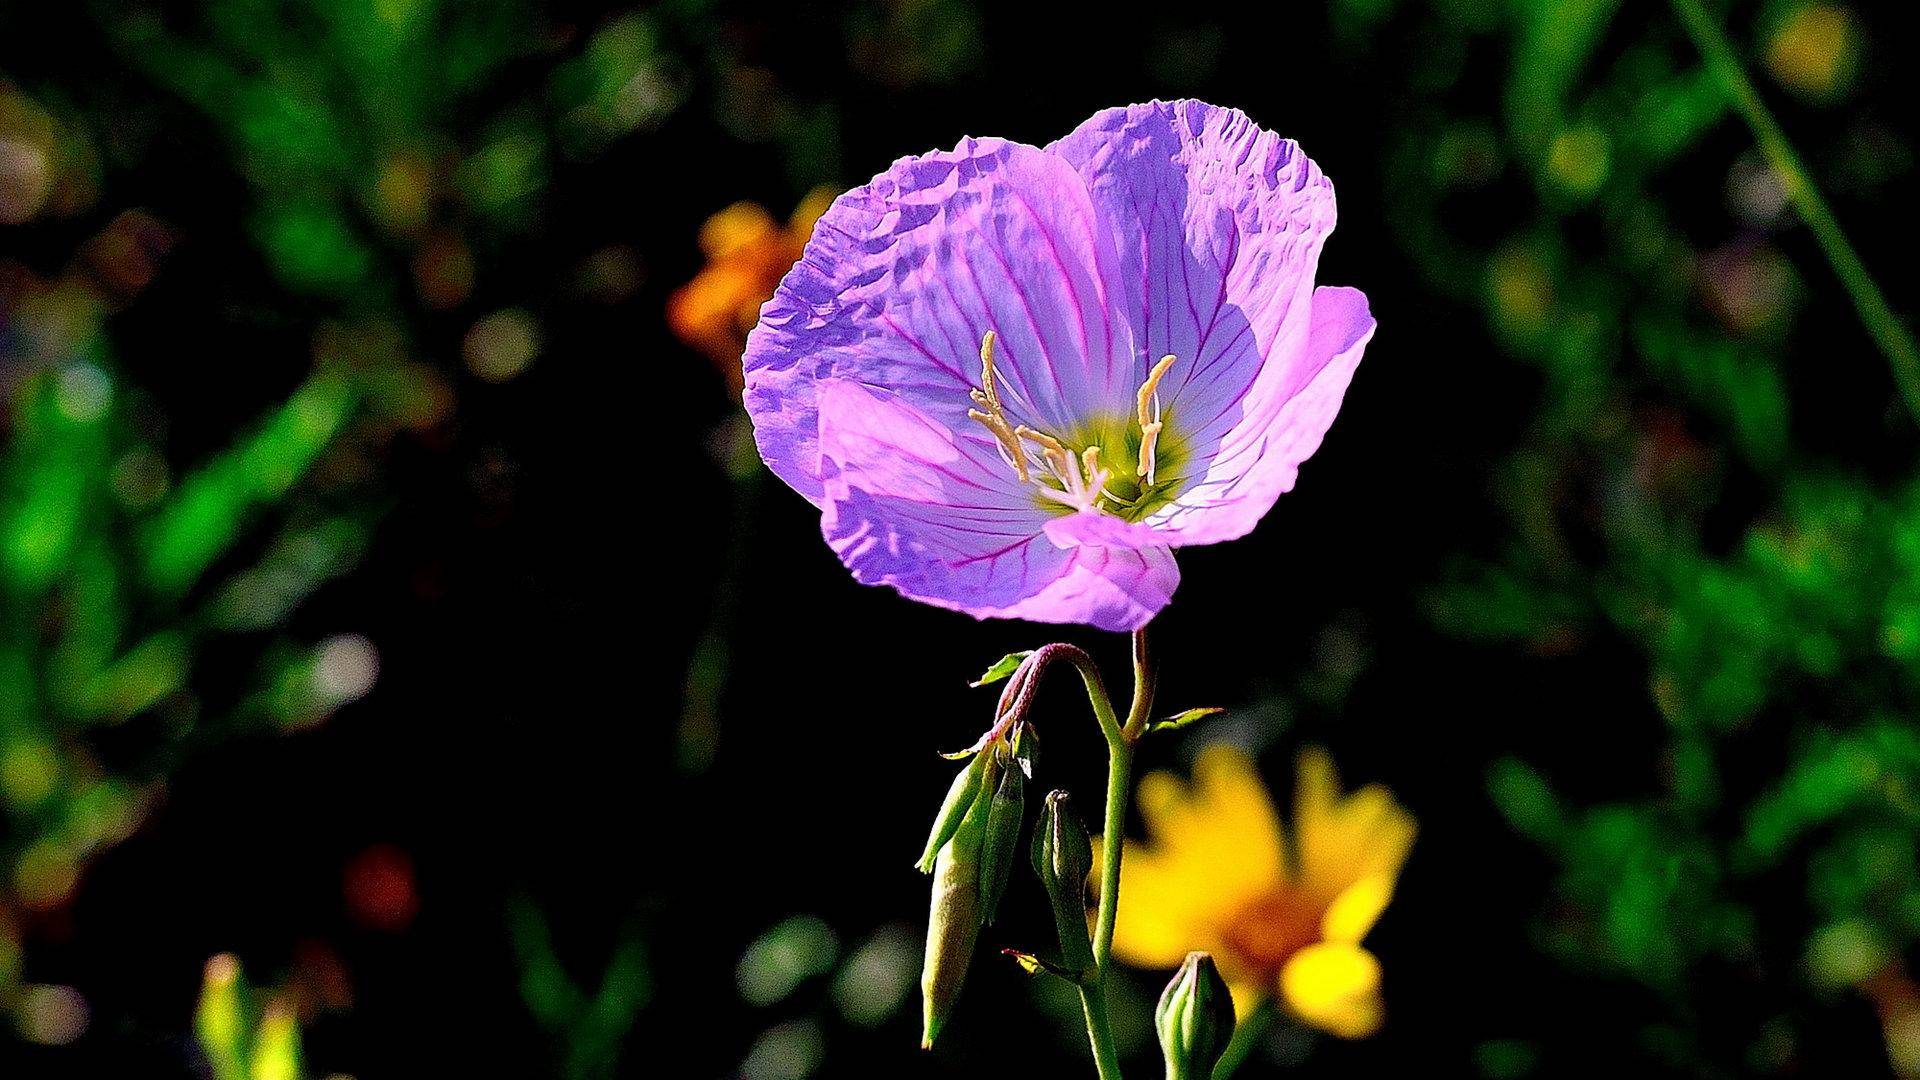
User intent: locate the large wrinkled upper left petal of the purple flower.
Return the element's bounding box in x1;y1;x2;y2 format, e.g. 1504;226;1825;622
743;138;1135;503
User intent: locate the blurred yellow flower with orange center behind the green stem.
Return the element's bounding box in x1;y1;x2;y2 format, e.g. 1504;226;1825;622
1114;746;1413;1038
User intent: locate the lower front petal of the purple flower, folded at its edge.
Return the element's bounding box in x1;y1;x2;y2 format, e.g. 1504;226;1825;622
816;379;1179;630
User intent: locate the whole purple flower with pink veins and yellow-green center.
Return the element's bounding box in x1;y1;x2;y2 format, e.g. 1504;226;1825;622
745;102;1373;630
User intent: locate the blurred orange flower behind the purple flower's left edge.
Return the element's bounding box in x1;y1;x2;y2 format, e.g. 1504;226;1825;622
666;188;835;394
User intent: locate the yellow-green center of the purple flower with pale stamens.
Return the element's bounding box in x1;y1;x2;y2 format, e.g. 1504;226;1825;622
968;331;1181;521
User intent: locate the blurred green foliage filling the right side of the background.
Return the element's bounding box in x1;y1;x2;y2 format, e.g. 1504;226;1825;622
1336;0;1920;1076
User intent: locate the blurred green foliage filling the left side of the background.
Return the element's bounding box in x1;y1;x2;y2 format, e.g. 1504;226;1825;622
0;0;680;1037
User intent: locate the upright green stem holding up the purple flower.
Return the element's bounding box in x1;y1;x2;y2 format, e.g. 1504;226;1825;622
1075;628;1154;1080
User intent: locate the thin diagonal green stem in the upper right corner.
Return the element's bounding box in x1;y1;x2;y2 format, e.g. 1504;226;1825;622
1672;0;1920;419
